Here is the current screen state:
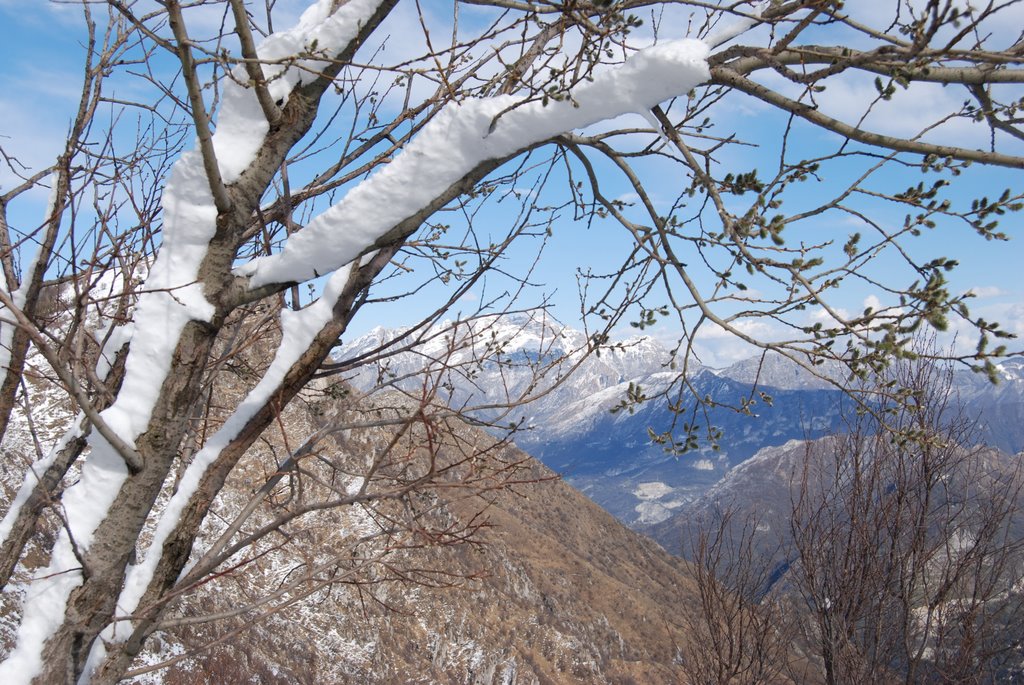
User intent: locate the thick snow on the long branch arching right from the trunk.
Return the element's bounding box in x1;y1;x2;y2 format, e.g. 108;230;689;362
238;39;709;287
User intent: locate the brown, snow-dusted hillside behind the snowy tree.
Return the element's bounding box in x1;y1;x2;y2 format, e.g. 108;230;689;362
0;327;720;685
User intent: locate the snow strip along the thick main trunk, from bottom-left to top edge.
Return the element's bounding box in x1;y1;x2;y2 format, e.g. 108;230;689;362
0;0;380;683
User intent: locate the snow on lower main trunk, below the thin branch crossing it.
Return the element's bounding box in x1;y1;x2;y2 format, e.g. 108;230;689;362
0;144;224;683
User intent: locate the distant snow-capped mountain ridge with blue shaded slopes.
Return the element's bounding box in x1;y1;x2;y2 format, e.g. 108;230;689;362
336;314;1024;526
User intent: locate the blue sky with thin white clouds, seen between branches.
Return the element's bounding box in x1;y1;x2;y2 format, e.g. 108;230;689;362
0;0;1024;366
